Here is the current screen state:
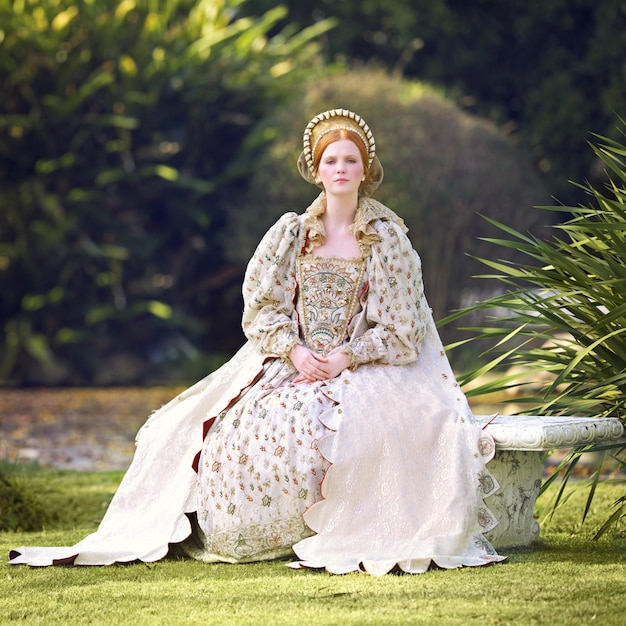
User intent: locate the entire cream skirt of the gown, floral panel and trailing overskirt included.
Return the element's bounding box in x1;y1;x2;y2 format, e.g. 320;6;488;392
10;326;505;574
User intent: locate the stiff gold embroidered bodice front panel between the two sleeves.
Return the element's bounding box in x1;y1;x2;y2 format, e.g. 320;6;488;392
297;256;365;355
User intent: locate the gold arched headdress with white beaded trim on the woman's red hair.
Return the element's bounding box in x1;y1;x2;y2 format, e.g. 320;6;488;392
298;109;383;195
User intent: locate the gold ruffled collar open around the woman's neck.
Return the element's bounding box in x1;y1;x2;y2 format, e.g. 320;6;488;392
299;192;408;256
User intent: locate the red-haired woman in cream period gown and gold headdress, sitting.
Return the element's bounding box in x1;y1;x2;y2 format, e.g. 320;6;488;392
11;109;505;574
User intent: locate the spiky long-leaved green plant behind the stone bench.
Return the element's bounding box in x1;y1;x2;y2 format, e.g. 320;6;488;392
440;120;626;537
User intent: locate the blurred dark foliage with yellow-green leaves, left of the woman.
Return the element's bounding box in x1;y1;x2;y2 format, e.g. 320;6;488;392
0;0;330;383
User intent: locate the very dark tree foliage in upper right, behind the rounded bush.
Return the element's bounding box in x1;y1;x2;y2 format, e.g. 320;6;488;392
241;0;626;202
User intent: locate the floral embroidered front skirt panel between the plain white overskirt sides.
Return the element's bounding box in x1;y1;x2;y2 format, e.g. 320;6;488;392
186;360;335;562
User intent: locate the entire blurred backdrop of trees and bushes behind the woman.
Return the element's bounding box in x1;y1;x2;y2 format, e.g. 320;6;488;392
0;0;626;385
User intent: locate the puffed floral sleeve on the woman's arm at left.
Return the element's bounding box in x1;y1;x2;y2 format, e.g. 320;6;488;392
242;213;302;358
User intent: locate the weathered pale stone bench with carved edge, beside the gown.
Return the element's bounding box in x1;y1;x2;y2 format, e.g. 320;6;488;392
476;415;624;548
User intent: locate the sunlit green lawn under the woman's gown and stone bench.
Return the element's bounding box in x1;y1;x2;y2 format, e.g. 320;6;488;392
0;466;626;626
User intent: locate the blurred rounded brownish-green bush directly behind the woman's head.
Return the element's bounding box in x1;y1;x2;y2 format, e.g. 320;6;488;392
227;68;553;352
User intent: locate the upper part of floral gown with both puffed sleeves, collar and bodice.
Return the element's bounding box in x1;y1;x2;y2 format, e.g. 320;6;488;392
242;205;432;369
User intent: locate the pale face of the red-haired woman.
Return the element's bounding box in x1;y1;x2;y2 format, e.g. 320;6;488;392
317;139;365;195
